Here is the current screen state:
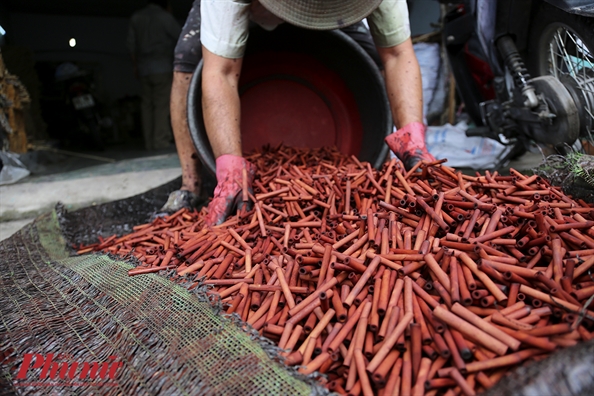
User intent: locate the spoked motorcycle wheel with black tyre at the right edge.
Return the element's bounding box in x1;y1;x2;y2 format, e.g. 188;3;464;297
528;3;594;144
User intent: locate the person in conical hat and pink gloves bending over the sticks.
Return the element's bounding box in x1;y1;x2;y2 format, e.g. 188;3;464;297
163;0;434;225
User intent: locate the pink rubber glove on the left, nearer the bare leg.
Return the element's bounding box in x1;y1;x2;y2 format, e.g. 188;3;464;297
205;154;256;225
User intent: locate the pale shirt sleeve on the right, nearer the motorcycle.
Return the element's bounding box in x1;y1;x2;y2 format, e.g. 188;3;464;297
367;0;410;48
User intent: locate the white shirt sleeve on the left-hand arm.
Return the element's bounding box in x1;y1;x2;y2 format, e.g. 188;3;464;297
200;0;250;59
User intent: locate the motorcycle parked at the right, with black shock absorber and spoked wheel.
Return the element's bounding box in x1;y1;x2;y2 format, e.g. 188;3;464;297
440;0;594;166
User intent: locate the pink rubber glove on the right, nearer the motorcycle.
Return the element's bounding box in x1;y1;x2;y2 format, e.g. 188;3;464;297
385;122;435;169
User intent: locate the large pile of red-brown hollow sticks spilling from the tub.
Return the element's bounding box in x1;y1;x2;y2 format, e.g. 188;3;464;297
79;147;594;395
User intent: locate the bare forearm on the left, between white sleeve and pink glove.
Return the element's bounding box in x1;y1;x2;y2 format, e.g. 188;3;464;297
202;47;242;158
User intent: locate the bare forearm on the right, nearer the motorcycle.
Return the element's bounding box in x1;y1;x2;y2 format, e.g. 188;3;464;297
378;39;423;128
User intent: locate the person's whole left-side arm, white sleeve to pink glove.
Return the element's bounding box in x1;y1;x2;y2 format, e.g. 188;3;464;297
200;0;256;225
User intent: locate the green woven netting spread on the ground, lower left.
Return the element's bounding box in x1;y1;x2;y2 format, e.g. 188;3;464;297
0;212;322;395
